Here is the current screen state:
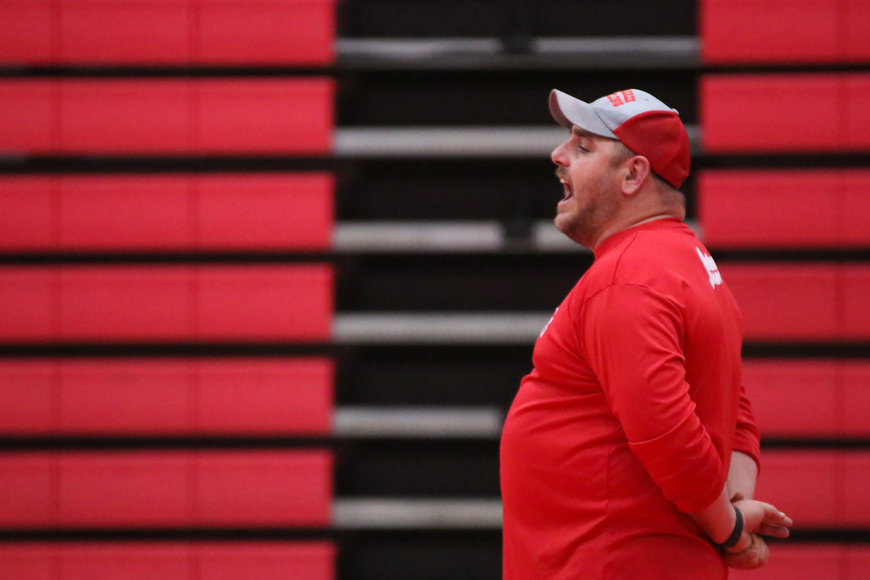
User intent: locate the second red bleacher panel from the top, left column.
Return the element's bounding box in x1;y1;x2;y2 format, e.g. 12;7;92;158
0;78;333;155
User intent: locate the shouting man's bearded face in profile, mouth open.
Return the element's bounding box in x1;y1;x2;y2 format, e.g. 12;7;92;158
551;127;621;248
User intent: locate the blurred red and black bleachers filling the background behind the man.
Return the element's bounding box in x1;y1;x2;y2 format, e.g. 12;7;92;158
0;0;870;580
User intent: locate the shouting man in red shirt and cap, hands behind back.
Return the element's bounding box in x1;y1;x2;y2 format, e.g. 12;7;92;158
501;89;792;580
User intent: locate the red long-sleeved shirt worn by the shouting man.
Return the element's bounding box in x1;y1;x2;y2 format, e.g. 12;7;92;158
501;218;759;580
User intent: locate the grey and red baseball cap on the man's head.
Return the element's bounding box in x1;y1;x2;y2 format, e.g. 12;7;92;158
550;89;691;187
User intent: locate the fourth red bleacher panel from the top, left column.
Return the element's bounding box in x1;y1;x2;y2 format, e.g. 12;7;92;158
0;264;332;343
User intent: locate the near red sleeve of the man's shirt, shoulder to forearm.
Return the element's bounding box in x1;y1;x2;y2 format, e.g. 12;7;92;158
578;285;728;512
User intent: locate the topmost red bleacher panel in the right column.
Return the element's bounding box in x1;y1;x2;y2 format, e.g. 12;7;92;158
699;0;870;64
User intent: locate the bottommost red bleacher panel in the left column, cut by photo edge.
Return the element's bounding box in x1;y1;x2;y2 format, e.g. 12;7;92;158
0;541;335;580
